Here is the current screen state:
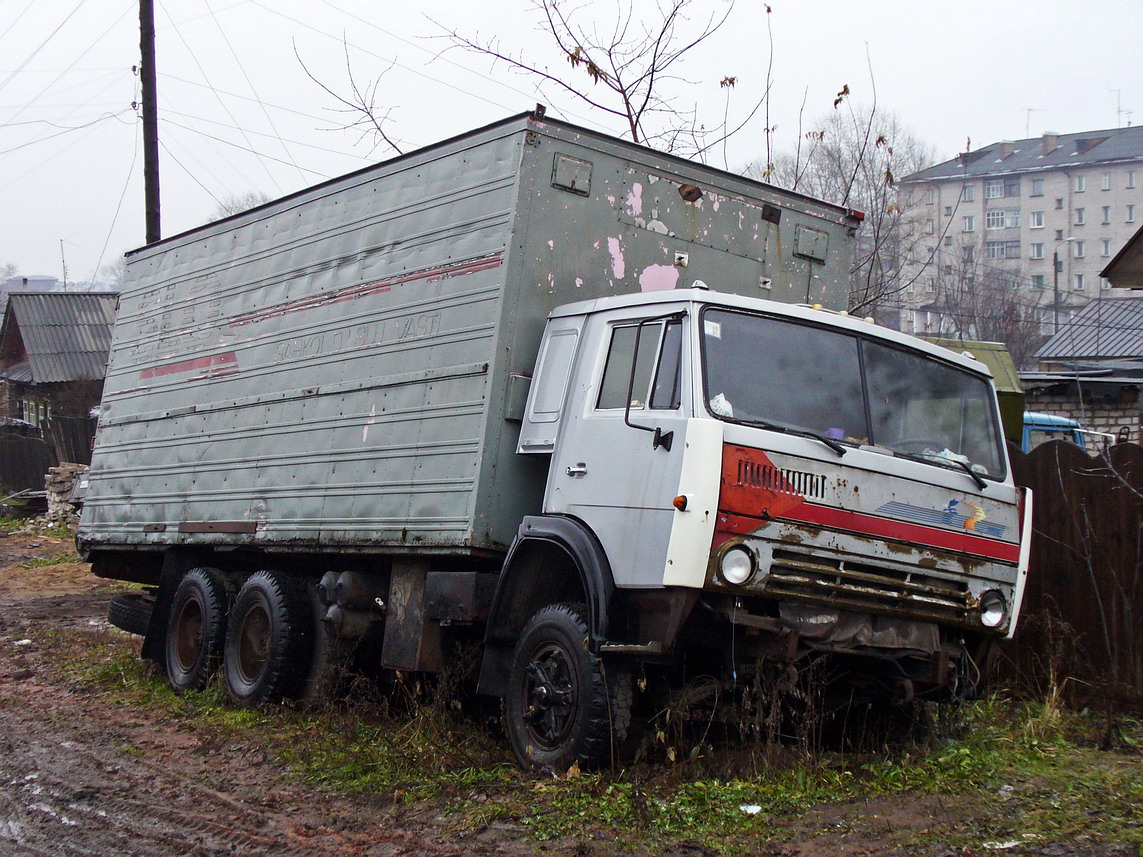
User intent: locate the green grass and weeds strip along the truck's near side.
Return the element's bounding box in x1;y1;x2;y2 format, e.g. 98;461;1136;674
35;634;1143;854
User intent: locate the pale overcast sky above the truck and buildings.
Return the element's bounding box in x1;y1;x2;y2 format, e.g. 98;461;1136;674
0;0;1143;281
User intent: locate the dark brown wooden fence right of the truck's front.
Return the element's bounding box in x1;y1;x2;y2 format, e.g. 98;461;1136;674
998;441;1143;707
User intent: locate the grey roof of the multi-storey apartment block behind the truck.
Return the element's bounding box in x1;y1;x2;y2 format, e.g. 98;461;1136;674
901;126;1143;183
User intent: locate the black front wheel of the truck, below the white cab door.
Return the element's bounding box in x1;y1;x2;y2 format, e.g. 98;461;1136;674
504;604;632;771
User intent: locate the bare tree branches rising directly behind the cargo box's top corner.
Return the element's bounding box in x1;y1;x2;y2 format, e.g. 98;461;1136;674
438;0;733;151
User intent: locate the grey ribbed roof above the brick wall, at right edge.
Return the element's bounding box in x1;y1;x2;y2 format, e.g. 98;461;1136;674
1036;297;1143;363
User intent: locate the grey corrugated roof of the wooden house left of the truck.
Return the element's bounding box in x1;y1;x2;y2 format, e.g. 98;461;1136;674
5;291;118;384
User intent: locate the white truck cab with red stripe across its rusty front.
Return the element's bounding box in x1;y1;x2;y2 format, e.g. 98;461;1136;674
482;289;1031;763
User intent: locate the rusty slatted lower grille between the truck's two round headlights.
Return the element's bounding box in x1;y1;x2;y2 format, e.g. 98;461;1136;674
762;551;970;624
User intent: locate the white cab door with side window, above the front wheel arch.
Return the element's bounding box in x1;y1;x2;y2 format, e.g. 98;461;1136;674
544;310;692;586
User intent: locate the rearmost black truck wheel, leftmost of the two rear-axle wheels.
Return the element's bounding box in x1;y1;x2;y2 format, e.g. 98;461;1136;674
167;568;226;692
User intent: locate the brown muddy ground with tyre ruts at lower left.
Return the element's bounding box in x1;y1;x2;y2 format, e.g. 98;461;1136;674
0;535;1133;857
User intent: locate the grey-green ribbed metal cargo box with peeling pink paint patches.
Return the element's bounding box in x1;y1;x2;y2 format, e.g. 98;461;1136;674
79;115;857;553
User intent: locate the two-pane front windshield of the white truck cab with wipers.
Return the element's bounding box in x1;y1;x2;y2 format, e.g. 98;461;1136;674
702;309;1005;479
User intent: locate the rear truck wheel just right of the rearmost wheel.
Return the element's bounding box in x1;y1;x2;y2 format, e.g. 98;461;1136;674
223;571;314;707
